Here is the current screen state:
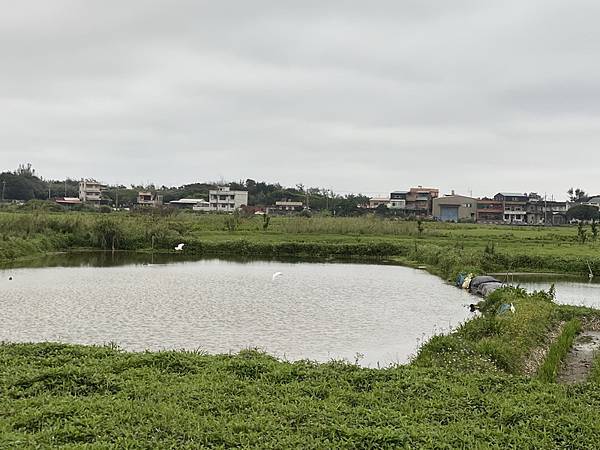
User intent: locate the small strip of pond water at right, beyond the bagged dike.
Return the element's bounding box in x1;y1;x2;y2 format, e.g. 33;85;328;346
509;275;600;308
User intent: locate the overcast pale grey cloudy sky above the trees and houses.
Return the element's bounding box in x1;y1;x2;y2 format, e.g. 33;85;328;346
0;0;600;198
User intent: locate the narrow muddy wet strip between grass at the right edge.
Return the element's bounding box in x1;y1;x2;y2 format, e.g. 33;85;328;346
556;331;600;384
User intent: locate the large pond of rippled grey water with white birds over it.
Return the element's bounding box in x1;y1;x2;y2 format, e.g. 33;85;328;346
0;254;473;367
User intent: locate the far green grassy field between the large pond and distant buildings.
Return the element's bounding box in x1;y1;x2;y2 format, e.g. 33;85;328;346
0;211;600;278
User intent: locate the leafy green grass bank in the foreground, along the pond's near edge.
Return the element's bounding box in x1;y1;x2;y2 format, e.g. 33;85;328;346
0;289;600;449
